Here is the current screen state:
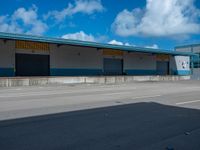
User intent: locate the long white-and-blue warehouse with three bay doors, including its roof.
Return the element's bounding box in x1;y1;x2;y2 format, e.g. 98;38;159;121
0;33;193;77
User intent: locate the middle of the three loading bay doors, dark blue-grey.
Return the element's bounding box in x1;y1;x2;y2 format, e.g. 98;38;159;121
103;58;123;75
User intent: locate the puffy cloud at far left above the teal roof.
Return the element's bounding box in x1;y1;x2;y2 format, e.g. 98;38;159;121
0;6;48;35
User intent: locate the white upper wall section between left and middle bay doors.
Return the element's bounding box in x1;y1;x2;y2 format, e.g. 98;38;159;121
50;44;103;69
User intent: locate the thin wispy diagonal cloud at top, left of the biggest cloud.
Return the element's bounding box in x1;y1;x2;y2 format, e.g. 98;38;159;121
44;0;104;21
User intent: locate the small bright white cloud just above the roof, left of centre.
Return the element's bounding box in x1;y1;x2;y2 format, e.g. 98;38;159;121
62;31;96;42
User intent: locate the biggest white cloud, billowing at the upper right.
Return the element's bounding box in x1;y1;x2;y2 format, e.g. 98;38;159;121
112;0;200;37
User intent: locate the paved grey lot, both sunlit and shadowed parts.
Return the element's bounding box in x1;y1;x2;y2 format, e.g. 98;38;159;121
0;81;200;150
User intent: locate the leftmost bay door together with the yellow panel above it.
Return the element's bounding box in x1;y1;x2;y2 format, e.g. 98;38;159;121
15;40;50;76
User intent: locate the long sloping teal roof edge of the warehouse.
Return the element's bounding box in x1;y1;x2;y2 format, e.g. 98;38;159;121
0;32;195;56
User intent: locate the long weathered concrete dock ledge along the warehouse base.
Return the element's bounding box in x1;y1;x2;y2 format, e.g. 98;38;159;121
0;76;190;87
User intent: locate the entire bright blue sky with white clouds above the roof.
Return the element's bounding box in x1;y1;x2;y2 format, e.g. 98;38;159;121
0;0;200;49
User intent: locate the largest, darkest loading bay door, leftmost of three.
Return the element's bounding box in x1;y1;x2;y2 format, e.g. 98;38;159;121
15;54;49;76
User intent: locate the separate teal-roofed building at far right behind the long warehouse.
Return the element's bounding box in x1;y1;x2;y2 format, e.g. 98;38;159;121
175;44;200;80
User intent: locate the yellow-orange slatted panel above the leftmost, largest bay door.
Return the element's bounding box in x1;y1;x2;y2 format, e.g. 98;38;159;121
15;40;50;51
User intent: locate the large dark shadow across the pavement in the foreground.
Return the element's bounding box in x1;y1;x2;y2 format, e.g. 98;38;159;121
0;103;200;150
